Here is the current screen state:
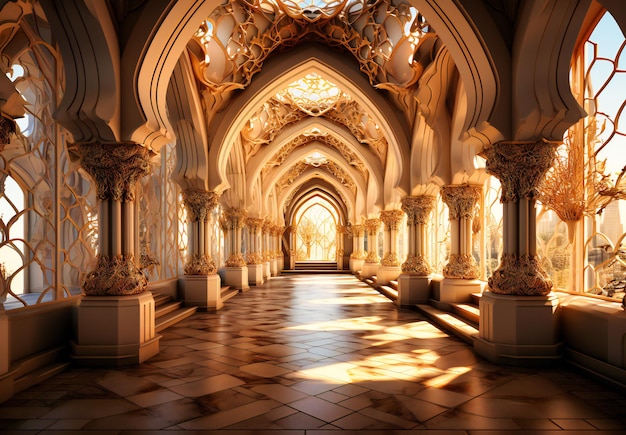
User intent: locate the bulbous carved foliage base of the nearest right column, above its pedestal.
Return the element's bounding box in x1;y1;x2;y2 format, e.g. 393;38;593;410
489;254;553;296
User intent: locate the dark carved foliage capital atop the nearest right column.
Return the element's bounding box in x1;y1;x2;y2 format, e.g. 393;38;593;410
479;141;558;202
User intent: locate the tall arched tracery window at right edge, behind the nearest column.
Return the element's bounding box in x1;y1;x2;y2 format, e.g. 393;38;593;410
537;3;626;300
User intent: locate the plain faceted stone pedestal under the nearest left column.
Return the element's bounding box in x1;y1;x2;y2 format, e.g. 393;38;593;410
71;291;161;367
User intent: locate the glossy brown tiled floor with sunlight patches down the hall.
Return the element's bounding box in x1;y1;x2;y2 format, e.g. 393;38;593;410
0;275;626;435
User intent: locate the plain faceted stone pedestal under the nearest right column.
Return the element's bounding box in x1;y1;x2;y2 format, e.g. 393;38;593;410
474;291;562;364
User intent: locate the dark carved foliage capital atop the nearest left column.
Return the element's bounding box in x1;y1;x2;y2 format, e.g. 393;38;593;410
68;142;154;202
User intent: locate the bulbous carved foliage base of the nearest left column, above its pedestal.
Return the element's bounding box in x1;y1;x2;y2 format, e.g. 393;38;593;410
82;254;148;296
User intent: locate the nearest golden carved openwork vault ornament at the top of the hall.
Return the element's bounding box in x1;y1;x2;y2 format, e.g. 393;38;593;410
190;0;431;99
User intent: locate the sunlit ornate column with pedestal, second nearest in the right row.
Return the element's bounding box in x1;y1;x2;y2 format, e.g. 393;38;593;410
439;185;482;303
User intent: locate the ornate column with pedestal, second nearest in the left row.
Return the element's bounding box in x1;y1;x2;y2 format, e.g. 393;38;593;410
180;190;224;311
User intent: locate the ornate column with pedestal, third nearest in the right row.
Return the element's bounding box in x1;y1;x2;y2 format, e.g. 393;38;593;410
396;195;435;306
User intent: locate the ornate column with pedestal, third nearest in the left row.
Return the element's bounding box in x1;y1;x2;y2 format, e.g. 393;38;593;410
220;208;250;291
